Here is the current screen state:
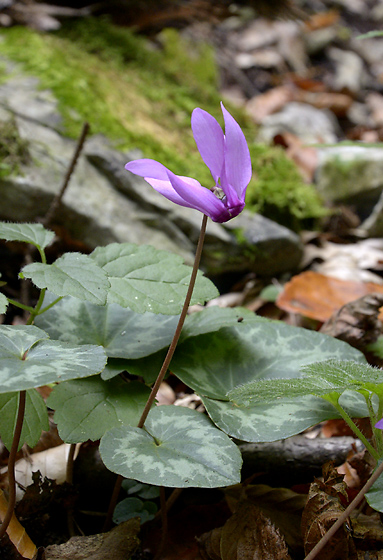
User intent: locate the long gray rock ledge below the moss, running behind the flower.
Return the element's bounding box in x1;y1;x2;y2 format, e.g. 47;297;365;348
0;57;302;275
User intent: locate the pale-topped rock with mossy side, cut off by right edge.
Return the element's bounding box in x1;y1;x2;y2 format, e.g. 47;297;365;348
315;145;383;218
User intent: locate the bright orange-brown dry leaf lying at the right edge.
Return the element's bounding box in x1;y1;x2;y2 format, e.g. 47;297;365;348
276;271;383;322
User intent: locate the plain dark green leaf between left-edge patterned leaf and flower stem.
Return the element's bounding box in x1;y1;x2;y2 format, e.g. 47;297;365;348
47;375;150;443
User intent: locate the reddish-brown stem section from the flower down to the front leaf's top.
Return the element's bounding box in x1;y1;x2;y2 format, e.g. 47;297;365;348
137;215;207;428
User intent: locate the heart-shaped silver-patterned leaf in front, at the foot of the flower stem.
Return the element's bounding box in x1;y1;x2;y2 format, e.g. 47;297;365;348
100;406;242;488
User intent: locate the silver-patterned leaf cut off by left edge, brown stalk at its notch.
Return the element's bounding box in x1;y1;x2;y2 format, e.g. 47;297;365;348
0;325;106;393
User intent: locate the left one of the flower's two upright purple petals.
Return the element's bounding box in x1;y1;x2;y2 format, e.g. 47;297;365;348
191;108;225;182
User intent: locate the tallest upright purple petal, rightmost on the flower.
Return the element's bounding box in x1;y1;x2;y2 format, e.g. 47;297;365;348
221;103;252;201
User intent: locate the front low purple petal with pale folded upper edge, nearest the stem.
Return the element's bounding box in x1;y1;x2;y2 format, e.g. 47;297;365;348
168;171;225;220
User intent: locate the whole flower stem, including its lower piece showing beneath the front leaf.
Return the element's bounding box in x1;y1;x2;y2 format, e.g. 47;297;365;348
103;215;207;531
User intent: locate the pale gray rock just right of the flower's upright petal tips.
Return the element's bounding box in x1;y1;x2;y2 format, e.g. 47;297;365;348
259;102;338;144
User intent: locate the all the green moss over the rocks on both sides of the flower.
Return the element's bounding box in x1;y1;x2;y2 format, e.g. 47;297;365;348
1;18;323;229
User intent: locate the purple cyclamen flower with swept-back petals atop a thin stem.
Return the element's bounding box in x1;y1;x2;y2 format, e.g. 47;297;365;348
125;103;251;223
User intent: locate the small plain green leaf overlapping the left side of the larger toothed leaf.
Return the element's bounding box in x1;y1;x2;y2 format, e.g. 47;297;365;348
20;253;110;305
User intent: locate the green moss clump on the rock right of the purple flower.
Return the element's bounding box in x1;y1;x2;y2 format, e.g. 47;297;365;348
246;144;328;231
